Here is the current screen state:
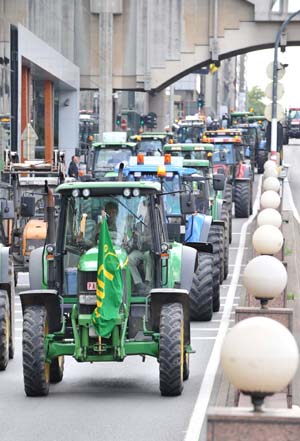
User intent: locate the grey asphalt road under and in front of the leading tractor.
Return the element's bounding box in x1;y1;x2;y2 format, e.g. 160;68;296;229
0;180;258;441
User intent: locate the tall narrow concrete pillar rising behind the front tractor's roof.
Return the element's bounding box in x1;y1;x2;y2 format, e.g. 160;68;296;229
99;7;113;133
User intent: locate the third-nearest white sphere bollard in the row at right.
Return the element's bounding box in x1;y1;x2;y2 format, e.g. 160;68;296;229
252;225;283;254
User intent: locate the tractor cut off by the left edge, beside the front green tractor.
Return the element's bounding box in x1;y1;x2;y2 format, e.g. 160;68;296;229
0;183;15;371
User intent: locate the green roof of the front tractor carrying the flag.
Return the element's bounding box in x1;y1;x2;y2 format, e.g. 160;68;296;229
56;181;161;193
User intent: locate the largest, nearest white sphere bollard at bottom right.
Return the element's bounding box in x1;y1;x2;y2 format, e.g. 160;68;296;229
221;317;299;394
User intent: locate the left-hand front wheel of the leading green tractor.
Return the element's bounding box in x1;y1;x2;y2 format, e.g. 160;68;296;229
23;305;50;397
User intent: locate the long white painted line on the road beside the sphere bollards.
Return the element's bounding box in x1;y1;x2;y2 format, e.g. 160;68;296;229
184;177;262;441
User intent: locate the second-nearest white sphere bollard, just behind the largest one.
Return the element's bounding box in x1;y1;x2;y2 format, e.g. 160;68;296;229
243;255;287;299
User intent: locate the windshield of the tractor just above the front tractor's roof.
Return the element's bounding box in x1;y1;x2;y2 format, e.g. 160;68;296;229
94;148;132;171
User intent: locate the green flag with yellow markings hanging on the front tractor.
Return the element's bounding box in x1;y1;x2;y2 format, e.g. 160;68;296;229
92;216;123;338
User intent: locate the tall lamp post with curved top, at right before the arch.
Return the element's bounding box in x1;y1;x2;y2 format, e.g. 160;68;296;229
271;9;300;157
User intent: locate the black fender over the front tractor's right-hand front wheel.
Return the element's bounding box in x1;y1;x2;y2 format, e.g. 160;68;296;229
150;288;191;344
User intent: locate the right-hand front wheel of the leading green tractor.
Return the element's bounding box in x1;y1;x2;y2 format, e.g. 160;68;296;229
159;303;184;397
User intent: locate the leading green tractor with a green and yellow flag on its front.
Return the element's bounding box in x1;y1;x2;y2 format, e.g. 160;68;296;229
20;181;197;396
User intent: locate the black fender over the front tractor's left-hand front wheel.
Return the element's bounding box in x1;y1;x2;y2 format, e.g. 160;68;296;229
19;289;62;333
